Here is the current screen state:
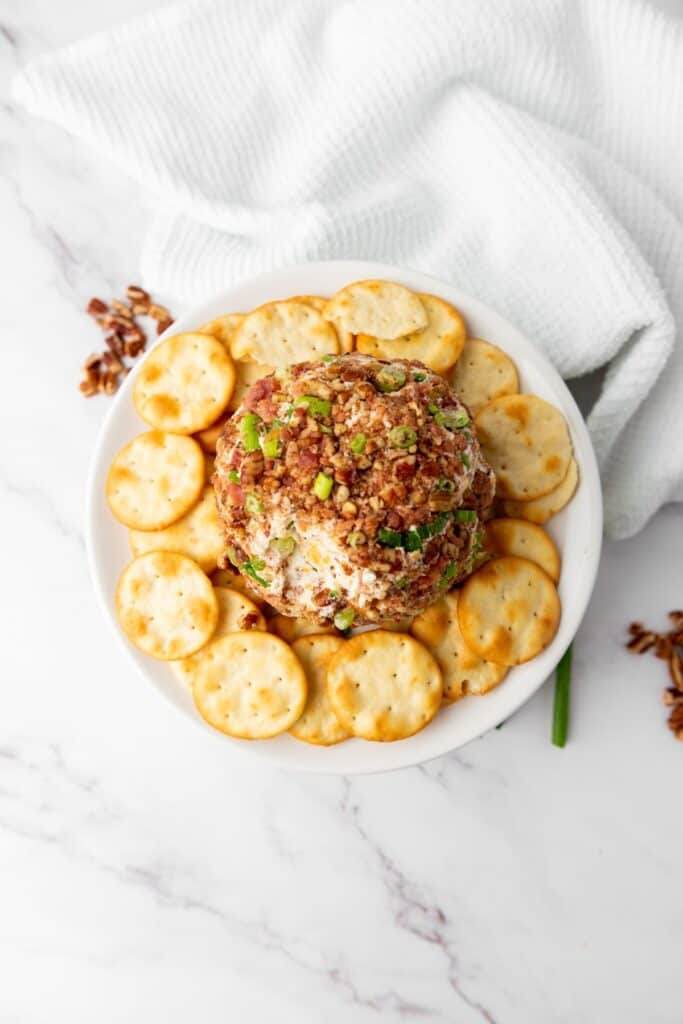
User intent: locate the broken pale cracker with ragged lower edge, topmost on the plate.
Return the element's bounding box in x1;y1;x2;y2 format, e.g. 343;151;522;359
324;281;428;338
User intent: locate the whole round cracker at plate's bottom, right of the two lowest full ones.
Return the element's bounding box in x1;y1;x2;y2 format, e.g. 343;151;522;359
328;630;443;741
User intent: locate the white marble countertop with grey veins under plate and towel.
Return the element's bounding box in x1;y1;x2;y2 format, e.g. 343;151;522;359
0;0;683;1024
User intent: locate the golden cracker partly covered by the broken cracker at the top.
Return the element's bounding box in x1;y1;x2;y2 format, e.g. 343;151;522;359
355;294;466;374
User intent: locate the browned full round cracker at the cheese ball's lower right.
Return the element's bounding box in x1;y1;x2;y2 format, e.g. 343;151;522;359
458;555;560;665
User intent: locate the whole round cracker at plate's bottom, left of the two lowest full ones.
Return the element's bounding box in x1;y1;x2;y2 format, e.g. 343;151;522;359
190;630;306;739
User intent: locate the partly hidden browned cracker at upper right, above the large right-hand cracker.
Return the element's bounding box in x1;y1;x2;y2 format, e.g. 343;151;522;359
449;338;519;416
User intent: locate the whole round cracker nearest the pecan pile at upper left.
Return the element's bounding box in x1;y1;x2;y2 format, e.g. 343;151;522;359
133;332;234;434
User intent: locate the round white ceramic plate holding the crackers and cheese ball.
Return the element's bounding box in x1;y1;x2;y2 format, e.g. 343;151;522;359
86;260;602;775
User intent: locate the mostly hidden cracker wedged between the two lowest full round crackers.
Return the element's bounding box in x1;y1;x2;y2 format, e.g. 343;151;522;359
290;633;351;746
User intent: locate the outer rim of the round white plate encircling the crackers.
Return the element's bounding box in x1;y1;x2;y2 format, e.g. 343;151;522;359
85;259;602;775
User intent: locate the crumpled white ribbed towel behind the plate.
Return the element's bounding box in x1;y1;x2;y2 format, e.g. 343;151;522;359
14;0;683;537
